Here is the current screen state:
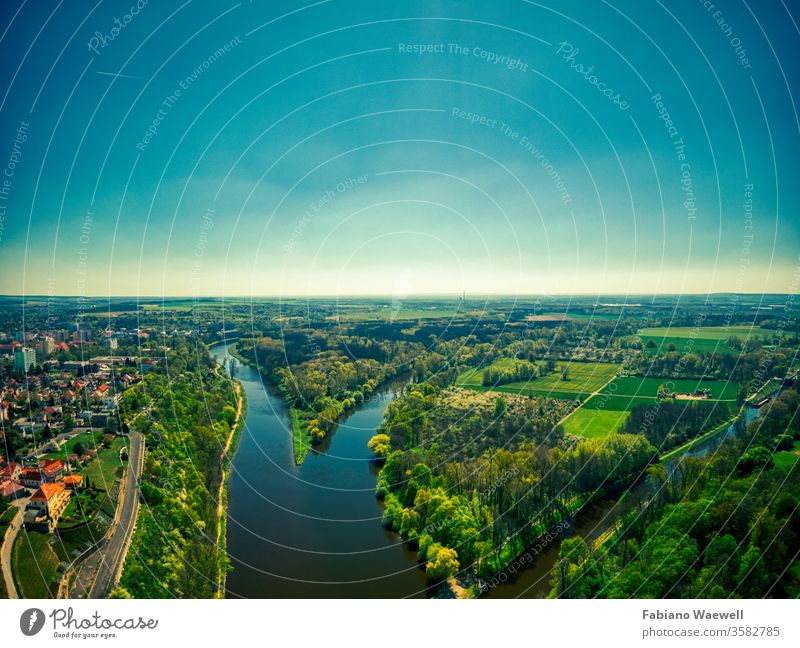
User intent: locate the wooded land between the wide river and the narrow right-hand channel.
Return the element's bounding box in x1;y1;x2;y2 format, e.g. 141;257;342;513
371;384;654;581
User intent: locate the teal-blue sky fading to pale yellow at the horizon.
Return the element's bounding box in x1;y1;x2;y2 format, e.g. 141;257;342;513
0;0;800;295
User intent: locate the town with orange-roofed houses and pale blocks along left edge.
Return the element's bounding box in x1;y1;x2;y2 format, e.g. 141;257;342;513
0;306;198;596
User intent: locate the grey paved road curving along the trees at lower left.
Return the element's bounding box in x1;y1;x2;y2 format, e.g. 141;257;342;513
72;432;144;598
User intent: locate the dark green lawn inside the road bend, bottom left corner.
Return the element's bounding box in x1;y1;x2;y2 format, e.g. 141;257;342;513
13;529;60;598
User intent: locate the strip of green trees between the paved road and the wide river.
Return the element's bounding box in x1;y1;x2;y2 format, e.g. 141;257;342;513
115;339;236;598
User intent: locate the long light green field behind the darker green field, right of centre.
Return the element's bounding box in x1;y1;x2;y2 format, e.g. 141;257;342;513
456;359;619;399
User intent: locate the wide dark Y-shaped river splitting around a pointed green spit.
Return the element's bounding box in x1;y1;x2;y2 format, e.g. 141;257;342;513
211;345;426;598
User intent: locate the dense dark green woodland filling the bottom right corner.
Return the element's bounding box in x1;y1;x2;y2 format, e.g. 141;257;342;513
552;382;800;598
